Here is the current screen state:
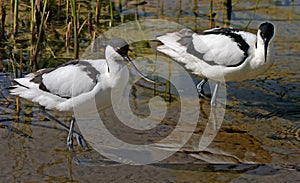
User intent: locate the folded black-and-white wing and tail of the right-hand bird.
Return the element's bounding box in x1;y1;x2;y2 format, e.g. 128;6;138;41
157;28;256;72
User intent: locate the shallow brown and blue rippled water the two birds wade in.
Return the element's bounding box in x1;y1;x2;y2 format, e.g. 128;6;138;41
0;0;300;182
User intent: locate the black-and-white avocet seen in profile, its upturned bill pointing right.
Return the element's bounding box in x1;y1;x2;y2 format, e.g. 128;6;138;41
10;38;152;149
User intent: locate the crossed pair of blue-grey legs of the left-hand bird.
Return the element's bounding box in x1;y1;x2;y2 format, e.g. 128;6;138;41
42;107;88;149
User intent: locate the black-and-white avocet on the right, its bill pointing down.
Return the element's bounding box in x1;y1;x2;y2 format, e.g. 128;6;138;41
157;22;275;105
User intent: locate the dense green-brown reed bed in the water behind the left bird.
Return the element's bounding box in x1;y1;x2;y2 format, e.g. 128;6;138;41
0;0;119;73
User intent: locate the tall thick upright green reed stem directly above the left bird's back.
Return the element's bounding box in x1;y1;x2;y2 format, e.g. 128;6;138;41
71;0;79;59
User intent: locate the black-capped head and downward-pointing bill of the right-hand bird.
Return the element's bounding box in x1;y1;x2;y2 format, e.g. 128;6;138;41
257;22;275;62
